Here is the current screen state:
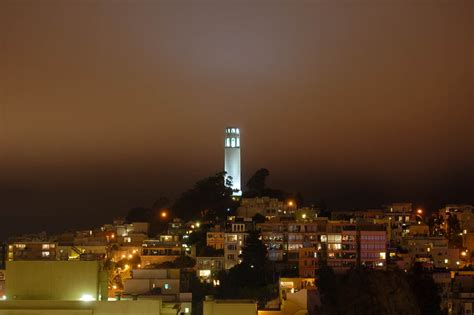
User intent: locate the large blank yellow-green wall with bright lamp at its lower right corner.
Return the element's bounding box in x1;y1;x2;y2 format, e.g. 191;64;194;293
5;261;107;301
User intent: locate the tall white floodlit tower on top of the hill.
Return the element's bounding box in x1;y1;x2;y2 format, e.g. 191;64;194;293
224;127;242;196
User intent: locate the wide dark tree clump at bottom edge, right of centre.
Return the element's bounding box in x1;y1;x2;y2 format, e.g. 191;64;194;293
316;267;440;315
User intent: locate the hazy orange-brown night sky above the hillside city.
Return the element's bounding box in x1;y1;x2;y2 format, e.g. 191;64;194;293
0;0;474;238
